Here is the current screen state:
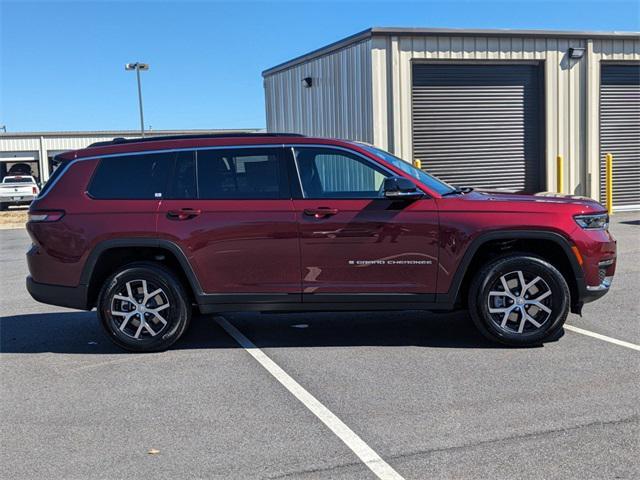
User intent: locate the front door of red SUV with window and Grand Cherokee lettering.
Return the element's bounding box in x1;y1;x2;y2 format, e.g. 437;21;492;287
292;147;438;302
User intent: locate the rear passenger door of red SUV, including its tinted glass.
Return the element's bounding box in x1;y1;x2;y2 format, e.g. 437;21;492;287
158;147;300;303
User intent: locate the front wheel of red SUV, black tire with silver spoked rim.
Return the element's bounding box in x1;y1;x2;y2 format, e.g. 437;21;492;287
468;254;571;346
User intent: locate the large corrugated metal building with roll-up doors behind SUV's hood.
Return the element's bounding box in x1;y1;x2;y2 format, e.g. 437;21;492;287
263;28;640;210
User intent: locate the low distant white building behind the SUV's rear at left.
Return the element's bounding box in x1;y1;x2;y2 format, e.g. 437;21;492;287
0;129;257;183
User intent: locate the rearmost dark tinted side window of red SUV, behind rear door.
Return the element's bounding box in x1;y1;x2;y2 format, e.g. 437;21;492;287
89;153;175;200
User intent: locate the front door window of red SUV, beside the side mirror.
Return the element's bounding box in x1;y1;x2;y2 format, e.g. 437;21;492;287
295;147;389;198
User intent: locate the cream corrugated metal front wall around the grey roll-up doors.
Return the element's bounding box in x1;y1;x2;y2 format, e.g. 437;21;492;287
372;35;640;198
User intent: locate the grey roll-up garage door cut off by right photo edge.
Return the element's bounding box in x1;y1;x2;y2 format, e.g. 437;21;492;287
600;65;640;210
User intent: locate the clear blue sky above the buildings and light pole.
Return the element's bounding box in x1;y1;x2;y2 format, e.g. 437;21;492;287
0;0;640;131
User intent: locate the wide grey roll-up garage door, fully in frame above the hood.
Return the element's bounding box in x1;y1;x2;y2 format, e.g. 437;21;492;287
412;64;543;192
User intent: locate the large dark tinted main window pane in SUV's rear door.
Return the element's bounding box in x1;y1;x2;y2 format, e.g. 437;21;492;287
196;149;288;199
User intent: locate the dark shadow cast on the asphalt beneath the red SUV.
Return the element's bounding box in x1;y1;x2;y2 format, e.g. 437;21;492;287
0;311;560;355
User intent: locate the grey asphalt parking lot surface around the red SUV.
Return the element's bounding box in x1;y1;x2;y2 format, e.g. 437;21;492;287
0;213;640;479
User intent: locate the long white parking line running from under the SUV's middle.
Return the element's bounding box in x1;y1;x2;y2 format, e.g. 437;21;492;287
216;317;404;480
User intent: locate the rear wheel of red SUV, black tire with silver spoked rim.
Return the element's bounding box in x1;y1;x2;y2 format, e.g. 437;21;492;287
97;262;191;352
